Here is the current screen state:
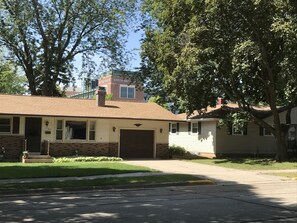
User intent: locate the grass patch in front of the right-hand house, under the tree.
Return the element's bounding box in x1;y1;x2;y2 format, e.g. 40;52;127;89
190;158;297;170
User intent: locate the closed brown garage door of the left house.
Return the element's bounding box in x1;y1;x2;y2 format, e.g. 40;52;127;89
120;130;154;158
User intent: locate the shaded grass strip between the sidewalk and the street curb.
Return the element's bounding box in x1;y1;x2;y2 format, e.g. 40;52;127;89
0;174;212;192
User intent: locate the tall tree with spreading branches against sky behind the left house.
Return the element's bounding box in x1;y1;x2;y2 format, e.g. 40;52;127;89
0;0;135;96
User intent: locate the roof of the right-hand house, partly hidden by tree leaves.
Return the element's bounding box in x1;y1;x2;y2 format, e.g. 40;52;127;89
178;103;271;120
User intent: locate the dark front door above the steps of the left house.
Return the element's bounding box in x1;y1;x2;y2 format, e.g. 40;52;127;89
25;118;41;152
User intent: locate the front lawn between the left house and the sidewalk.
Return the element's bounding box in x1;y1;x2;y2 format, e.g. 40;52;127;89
0;162;154;179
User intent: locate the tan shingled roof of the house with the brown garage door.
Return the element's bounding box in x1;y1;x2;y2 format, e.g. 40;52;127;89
0;94;181;121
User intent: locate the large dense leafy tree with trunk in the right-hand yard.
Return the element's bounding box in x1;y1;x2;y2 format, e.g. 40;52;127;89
143;0;297;161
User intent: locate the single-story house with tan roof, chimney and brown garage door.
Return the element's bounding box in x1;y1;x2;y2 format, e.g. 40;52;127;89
0;90;180;159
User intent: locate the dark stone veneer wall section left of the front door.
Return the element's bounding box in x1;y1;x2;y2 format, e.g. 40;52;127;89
0;135;25;160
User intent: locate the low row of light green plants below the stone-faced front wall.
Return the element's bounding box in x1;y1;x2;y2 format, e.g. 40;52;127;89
54;156;123;163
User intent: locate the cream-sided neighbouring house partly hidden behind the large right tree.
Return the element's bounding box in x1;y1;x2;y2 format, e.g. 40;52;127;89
169;104;297;157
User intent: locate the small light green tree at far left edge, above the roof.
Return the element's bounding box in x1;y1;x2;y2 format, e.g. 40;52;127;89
0;59;27;94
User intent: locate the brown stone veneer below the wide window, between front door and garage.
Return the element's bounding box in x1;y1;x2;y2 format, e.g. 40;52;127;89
43;142;118;157
